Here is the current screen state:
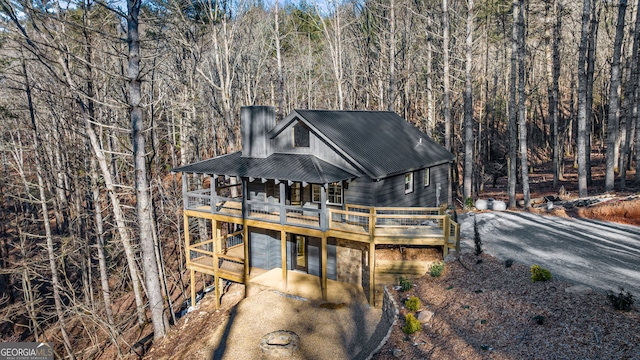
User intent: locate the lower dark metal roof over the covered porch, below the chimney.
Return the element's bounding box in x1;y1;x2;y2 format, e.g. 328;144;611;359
171;152;359;184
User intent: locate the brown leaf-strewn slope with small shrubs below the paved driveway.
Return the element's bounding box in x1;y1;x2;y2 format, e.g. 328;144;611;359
375;253;640;359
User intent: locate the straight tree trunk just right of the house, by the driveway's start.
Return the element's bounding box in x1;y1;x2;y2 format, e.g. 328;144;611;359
463;0;474;204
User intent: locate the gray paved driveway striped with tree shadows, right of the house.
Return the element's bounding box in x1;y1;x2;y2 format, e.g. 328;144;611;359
458;211;640;298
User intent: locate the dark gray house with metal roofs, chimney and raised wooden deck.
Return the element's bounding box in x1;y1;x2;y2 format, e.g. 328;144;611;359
173;106;459;303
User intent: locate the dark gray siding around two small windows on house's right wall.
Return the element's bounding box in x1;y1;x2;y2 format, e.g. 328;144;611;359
376;163;449;207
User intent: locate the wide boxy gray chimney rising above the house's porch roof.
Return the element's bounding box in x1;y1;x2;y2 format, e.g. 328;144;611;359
240;106;276;158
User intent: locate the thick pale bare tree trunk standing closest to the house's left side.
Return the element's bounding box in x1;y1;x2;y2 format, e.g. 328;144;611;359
127;0;169;340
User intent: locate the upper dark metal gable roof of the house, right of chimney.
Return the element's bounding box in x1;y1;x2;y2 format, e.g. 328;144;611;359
284;110;455;179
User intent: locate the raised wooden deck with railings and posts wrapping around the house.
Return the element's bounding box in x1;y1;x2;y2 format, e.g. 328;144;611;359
184;201;460;308
